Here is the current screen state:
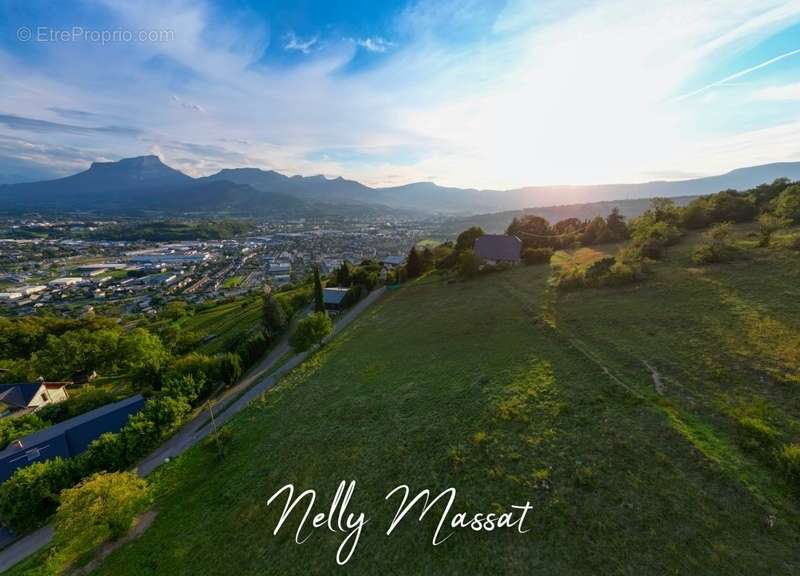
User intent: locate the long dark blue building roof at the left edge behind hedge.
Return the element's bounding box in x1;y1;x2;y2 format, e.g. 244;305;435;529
0;394;144;483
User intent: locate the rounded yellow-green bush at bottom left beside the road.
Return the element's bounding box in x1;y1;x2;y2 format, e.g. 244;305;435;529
48;472;152;571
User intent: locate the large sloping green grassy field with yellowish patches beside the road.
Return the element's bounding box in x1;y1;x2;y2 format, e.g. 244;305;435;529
14;230;800;576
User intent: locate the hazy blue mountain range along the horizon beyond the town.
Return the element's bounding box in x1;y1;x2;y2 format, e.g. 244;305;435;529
0;156;800;216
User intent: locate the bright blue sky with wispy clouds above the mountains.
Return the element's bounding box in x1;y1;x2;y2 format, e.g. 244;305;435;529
0;0;800;188
